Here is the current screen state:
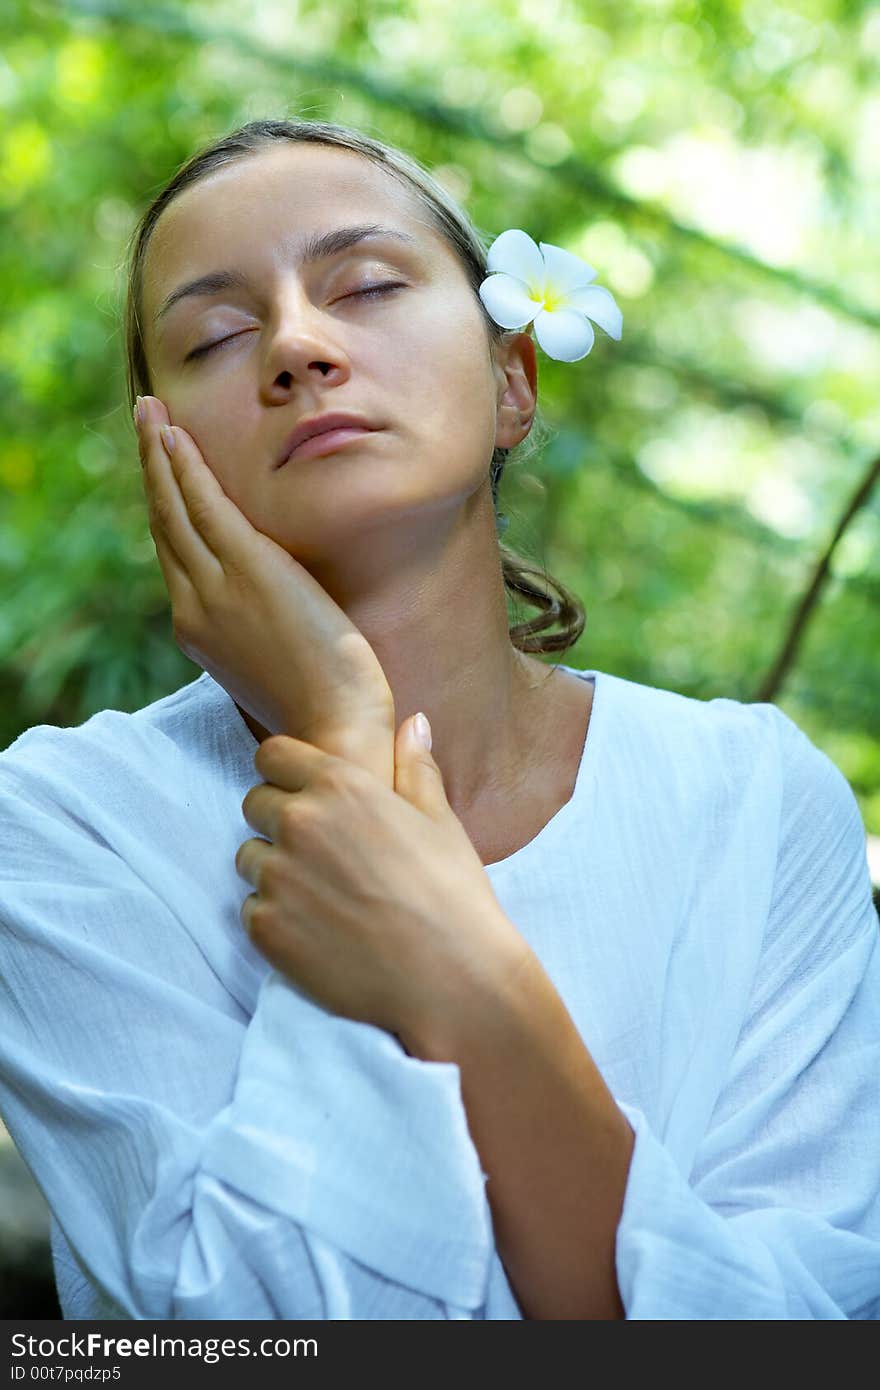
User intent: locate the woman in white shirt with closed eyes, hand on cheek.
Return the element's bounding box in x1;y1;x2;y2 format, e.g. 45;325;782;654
0;121;880;1319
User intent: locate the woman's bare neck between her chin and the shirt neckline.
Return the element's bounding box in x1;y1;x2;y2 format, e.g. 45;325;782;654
229;488;552;816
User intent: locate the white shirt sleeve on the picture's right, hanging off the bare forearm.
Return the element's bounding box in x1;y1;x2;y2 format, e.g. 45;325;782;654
606;709;880;1319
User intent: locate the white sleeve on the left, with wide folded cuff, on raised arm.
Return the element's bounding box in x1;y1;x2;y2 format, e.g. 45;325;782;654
0;759;494;1319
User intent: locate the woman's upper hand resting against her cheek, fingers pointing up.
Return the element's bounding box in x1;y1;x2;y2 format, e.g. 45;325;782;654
138;396;395;788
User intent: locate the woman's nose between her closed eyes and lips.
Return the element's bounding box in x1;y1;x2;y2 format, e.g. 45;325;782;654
263;284;350;404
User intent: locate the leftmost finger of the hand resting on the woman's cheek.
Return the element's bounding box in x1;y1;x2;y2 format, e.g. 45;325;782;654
140;396;222;596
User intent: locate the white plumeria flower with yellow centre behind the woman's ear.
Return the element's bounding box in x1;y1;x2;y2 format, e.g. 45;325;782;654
480;227;623;361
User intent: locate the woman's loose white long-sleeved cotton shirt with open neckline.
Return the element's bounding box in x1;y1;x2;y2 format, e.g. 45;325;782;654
0;666;880;1319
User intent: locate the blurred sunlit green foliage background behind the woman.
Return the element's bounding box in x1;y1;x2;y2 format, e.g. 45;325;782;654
0;0;880;861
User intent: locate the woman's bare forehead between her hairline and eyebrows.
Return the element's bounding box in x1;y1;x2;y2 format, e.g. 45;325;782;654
143;143;450;318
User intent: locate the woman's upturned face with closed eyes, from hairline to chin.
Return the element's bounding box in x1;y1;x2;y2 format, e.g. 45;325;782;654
142;145;534;557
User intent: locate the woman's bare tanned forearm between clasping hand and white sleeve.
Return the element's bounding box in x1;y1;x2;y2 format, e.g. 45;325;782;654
408;952;635;1319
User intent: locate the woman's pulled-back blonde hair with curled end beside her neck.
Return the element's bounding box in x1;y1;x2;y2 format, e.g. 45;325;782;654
124;120;585;653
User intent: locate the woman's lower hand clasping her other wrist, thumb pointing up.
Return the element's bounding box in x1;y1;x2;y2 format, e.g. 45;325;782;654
235;719;534;1059
